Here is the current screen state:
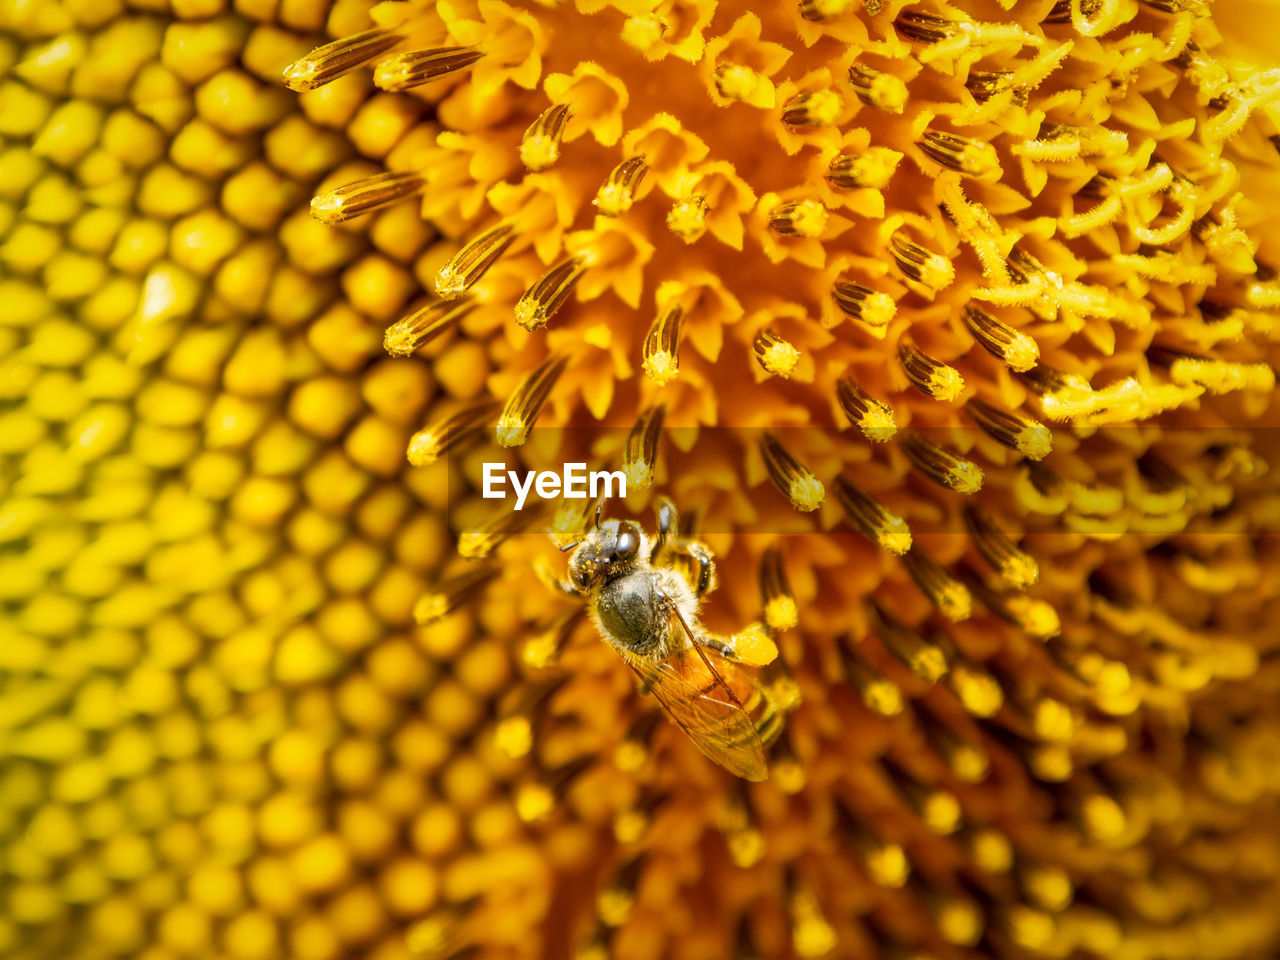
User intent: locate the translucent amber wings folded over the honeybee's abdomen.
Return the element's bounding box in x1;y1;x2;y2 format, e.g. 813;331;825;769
628;613;769;780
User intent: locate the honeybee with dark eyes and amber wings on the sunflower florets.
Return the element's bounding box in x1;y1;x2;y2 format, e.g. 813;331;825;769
556;498;782;781
